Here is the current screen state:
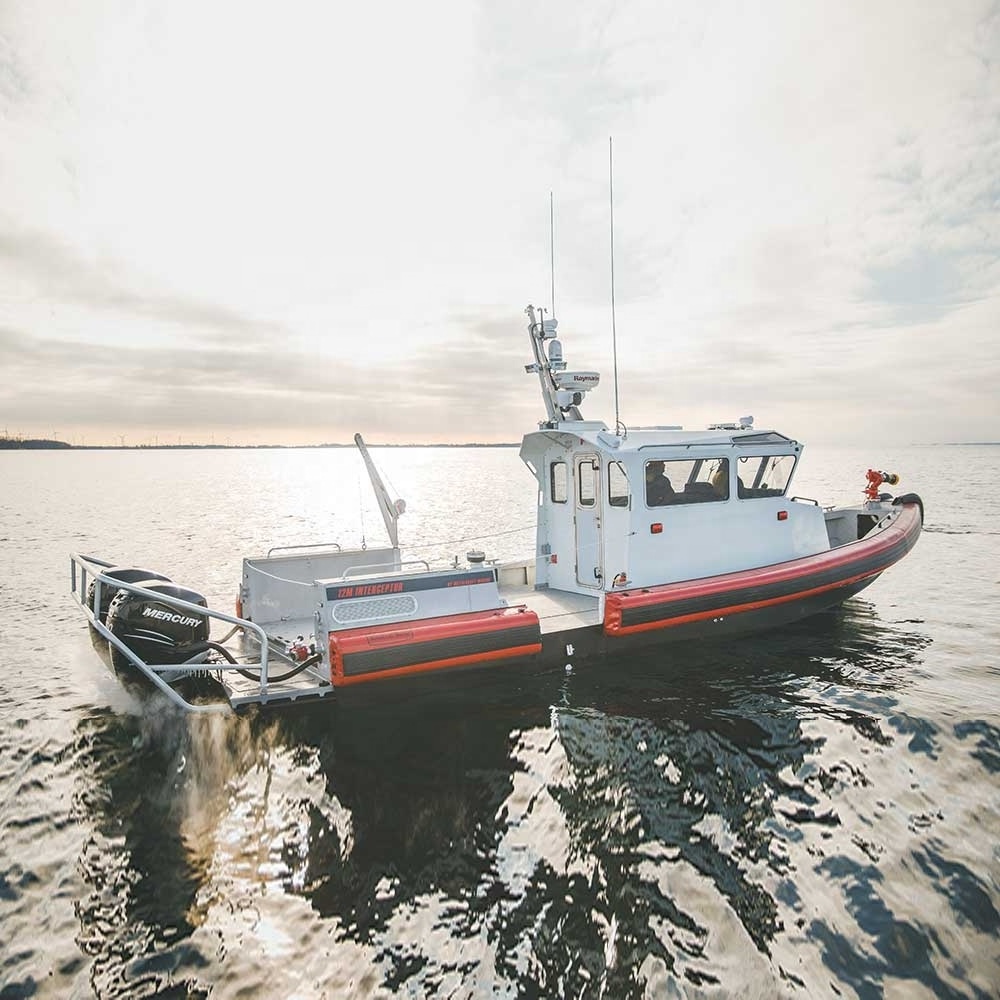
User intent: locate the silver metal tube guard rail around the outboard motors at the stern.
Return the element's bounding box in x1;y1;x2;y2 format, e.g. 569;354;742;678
70;554;269;713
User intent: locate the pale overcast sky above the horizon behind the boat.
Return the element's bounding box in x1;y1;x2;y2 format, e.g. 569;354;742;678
0;0;1000;444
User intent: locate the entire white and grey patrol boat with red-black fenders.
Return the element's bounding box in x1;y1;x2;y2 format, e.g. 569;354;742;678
71;306;923;711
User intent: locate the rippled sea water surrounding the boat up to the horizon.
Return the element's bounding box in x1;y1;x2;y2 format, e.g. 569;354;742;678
0;447;1000;997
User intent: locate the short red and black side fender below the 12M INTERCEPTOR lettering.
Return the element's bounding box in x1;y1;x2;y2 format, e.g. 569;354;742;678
329;606;542;687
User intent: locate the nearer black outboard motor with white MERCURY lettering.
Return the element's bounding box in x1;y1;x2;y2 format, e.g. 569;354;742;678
107;580;209;670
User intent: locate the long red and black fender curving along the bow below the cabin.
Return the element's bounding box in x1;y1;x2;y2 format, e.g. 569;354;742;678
604;504;921;636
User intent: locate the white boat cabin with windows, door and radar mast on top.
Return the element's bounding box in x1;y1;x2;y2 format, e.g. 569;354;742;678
520;308;830;594
